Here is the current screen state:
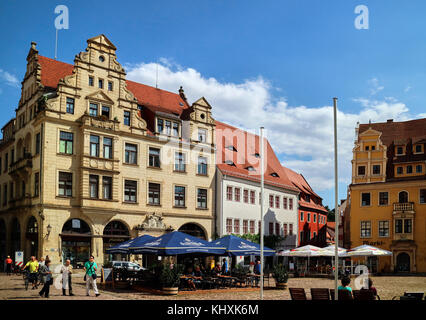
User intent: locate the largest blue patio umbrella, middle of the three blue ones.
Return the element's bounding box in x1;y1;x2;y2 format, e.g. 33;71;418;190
129;231;225;256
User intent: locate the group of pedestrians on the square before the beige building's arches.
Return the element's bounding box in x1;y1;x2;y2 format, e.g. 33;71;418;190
5;256;100;298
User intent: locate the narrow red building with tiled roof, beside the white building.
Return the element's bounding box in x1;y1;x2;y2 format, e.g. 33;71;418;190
283;167;328;247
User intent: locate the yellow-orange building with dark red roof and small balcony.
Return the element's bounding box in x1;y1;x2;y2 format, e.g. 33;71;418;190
345;119;426;272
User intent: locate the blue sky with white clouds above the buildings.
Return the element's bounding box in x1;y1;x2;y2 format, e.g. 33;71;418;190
0;0;426;207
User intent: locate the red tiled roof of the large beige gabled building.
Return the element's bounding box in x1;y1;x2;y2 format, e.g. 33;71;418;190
38;55;189;116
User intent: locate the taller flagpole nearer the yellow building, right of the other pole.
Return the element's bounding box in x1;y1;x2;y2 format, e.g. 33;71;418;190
333;98;339;300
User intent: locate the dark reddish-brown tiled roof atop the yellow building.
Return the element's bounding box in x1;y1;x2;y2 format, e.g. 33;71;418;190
359;118;426;146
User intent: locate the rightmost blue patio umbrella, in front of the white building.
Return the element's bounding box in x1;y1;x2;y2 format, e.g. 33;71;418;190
212;235;275;256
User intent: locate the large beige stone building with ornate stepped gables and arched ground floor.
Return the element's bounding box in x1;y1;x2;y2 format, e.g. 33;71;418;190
0;35;215;266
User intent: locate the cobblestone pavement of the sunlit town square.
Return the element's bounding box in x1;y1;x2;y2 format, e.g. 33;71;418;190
0;274;426;301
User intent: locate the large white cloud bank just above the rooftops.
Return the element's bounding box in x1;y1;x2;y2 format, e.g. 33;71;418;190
127;60;418;195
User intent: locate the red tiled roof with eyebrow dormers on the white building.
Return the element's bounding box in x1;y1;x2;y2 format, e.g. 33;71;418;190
215;121;298;191
